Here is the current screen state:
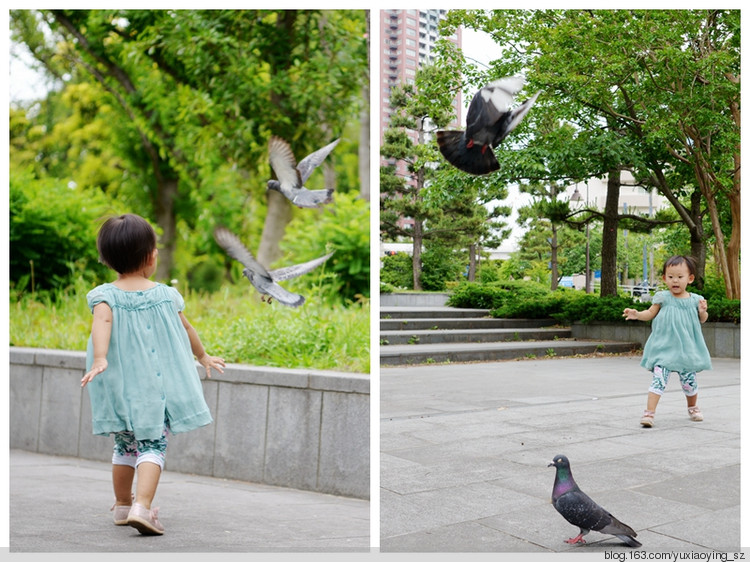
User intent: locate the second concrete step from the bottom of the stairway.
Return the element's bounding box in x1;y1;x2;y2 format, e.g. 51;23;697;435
380;328;571;345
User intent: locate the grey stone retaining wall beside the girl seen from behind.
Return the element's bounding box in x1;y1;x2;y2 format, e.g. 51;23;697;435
9;347;370;499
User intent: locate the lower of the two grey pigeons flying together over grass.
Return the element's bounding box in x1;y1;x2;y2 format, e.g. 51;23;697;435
214;227;333;307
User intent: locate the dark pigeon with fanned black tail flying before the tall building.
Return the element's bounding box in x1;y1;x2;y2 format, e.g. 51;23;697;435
437;76;539;176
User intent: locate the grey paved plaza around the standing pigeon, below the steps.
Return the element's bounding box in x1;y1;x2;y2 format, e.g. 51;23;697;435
380;356;740;555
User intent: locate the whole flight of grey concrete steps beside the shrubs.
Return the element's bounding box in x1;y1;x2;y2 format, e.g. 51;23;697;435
380;306;640;366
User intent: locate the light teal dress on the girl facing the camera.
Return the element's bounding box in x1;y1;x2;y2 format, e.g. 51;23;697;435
641;291;711;373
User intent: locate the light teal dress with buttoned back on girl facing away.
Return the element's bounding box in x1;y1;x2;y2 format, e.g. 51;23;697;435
86;283;213;440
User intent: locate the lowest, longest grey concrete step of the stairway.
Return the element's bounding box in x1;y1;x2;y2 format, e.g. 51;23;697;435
380;340;640;366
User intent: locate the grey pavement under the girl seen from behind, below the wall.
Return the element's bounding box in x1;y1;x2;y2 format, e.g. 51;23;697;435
9;450;370;553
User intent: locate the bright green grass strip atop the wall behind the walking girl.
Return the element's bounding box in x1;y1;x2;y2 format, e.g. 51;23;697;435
9;286;370;373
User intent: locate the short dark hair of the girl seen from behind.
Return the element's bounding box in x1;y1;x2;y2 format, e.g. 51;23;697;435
96;214;156;273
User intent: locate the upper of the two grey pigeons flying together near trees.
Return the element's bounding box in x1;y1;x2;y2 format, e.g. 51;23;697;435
268;136;341;207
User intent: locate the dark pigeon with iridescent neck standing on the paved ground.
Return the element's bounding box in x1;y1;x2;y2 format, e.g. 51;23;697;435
547;455;641;548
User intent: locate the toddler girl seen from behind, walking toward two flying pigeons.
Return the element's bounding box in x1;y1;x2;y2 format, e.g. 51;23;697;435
81;214;224;535
